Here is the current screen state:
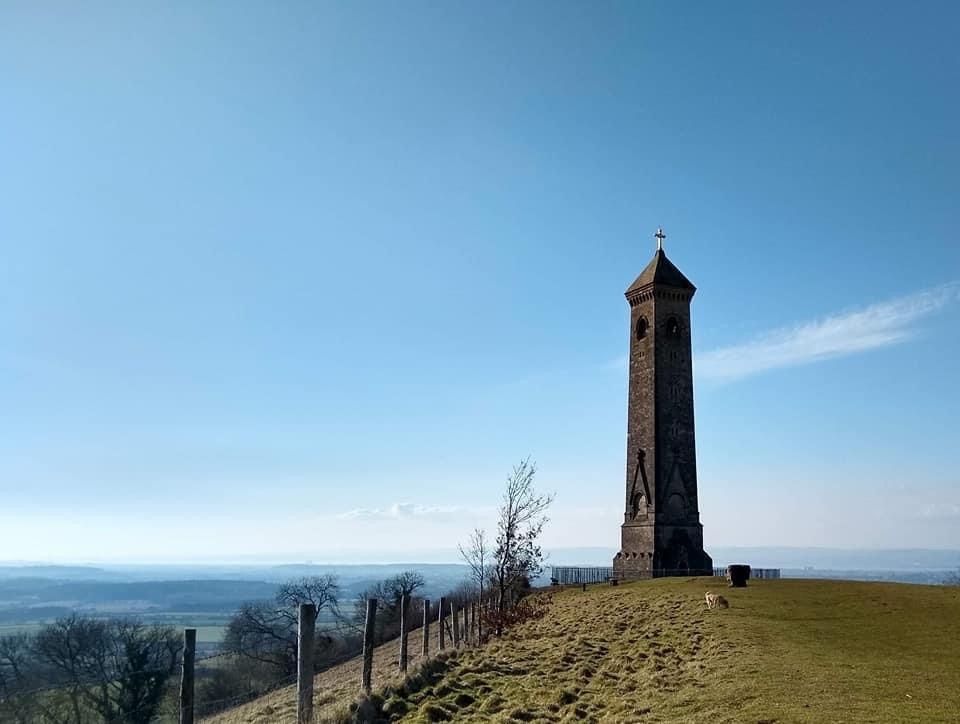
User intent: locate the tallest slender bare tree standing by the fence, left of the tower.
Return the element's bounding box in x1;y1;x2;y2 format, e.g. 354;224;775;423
492;458;553;634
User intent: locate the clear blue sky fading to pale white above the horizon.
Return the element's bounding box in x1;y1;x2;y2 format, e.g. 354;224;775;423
0;2;960;560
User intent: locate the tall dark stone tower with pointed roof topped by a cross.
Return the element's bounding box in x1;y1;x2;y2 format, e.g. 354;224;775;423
613;230;713;580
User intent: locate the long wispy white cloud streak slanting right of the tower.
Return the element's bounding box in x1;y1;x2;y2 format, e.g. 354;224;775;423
694;283;960;381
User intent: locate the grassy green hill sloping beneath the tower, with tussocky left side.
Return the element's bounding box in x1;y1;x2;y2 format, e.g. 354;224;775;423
202;579;960;724
